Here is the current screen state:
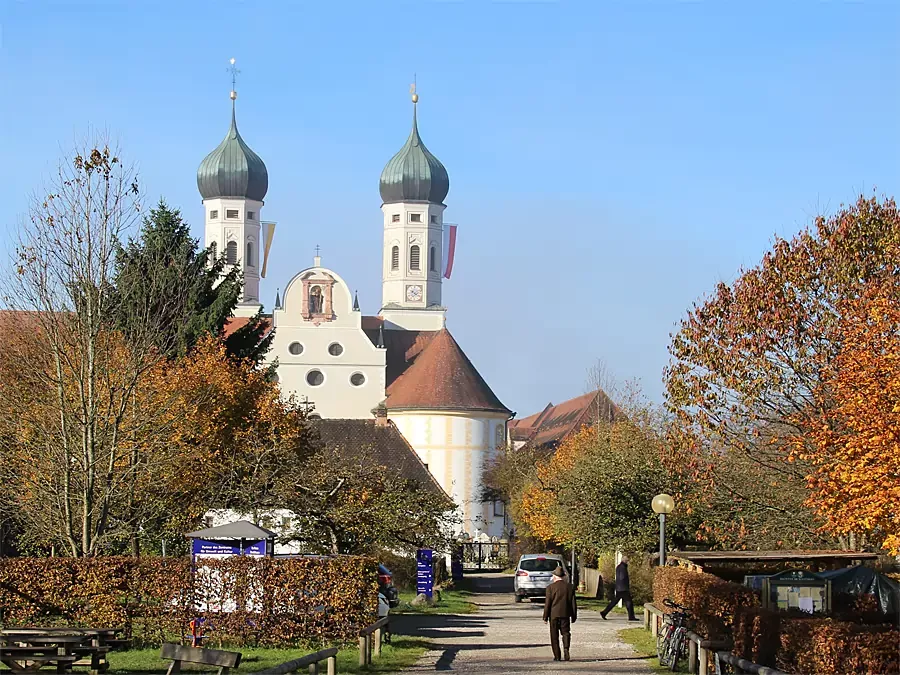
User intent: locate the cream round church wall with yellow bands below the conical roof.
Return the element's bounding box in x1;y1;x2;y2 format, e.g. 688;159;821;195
388;410;507;537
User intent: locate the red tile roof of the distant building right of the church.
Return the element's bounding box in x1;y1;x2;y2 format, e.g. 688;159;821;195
509;389;618;448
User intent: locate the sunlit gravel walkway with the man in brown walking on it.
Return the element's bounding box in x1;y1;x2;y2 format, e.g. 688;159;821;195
391;574;652;675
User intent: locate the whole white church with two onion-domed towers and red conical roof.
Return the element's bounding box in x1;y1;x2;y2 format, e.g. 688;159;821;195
197;87;514;537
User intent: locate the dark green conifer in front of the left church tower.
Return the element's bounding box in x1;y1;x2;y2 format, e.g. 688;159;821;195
115;200;274;363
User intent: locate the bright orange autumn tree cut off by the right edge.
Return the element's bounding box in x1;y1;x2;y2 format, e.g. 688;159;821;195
795;286;900;555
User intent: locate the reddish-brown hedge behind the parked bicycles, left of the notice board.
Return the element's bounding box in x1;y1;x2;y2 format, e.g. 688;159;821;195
653;567;759;639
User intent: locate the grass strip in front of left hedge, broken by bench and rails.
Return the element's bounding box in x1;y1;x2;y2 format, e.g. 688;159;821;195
109;635;428;675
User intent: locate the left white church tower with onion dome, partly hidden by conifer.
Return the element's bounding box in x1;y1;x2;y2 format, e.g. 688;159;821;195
197;60;269;316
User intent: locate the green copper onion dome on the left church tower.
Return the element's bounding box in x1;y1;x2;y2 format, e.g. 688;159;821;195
197;105;269;202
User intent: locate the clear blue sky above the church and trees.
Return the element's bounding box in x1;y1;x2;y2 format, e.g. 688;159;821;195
0;0;900;416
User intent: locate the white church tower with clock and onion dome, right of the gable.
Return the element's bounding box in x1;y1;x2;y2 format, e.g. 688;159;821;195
379;90;450;330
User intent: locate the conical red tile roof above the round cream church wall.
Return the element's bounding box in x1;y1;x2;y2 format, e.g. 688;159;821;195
384;328;511;414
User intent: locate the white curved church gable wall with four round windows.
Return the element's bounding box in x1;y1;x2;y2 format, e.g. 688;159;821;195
266;267;386;419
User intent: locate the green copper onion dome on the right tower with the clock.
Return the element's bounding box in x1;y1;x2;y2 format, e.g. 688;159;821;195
380;107;450;204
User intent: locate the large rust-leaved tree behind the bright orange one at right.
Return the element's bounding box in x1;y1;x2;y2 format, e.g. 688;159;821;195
665;197;900;548
